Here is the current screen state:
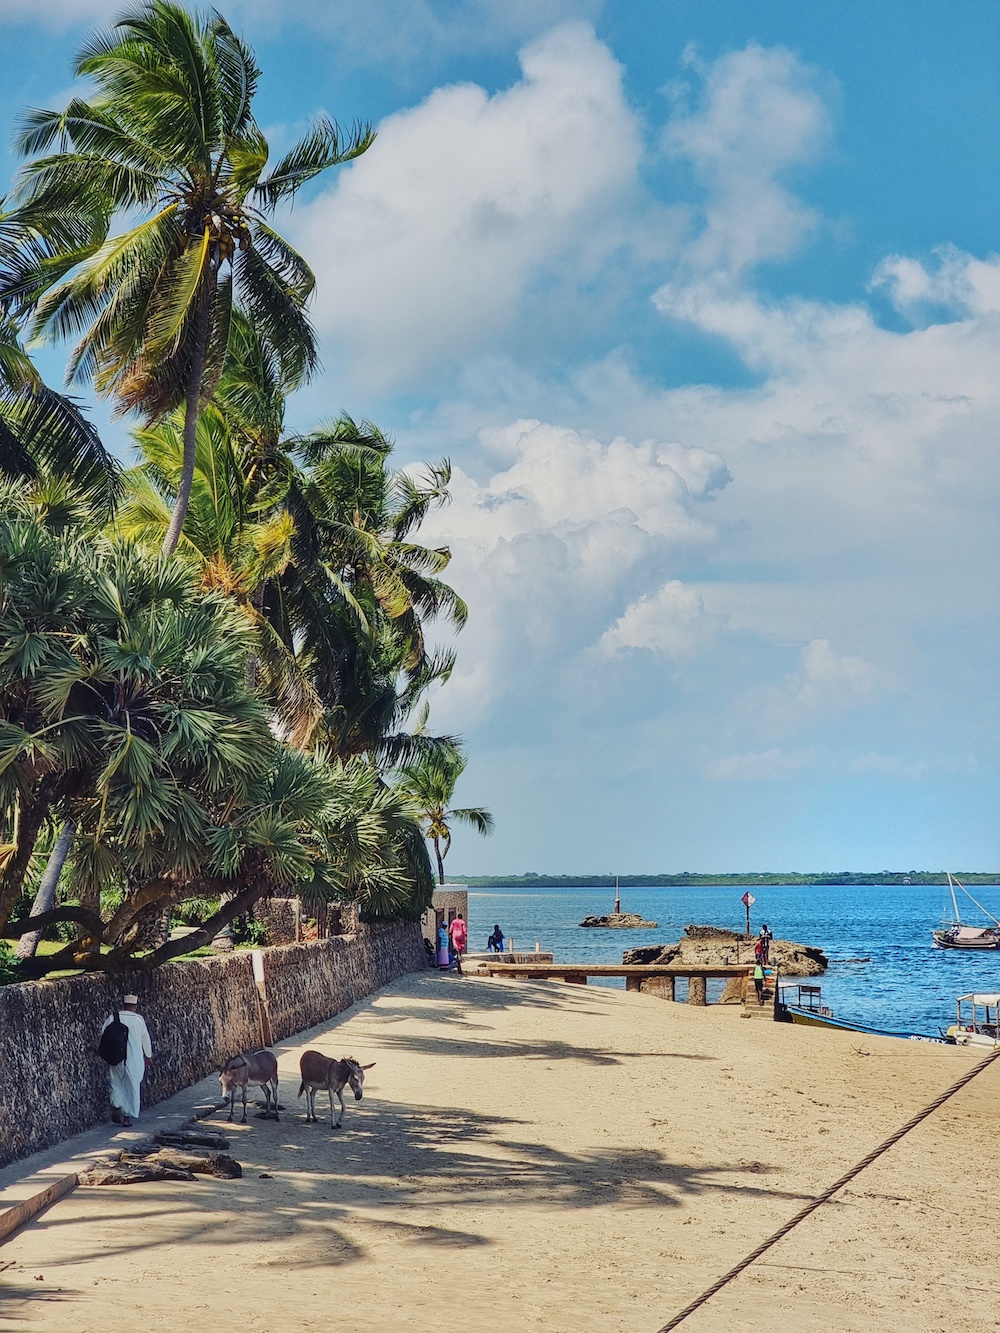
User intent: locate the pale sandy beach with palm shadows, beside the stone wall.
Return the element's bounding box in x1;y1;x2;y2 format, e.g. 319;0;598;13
0;974;1000;1333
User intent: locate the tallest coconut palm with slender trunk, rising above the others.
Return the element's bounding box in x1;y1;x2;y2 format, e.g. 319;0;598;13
0;0;375;555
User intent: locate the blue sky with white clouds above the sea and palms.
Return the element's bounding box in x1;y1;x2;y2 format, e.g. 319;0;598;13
0;0;1000;876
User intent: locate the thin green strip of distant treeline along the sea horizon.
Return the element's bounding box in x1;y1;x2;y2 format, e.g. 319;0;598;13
447;870;1000;889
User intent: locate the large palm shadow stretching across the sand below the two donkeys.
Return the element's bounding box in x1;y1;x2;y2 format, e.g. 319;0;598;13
21;1098;808;1270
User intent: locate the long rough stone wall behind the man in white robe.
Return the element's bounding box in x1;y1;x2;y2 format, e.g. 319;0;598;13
0;922;425;1166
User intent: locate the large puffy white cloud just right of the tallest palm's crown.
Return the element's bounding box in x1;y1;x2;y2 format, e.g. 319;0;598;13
291;24;641;388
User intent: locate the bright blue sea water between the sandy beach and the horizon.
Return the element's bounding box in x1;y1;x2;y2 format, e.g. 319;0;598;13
469;885;1000;1036
